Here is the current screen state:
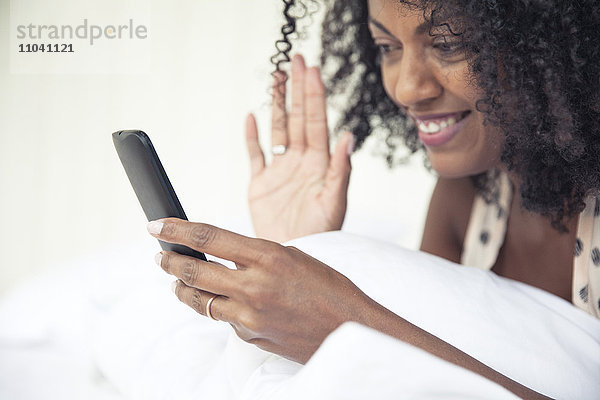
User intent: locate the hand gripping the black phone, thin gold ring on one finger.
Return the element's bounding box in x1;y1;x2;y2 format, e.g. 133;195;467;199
148;218;376;363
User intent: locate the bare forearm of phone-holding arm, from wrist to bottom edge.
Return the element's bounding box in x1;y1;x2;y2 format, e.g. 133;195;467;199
358;302;549;399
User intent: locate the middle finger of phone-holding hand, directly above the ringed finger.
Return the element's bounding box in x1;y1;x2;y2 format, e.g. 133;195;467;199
156;251;235;296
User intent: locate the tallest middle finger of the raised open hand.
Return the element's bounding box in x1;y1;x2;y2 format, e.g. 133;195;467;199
288;54;306;150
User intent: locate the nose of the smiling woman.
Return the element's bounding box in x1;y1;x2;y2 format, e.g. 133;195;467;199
384;51;444;109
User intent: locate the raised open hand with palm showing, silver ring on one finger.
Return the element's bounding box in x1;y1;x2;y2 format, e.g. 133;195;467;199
246;55;354;242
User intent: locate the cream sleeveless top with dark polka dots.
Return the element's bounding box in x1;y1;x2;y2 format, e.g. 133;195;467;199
461;173;600;318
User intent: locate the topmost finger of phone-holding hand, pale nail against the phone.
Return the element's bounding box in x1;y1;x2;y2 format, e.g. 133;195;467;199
147;218;274;267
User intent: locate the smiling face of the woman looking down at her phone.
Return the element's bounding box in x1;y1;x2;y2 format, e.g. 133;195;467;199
368;0;502;177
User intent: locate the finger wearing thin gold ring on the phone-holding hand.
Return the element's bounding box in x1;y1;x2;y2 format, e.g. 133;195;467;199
173;280;234;322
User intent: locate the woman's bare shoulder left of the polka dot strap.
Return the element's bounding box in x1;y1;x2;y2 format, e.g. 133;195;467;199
421;177;476;262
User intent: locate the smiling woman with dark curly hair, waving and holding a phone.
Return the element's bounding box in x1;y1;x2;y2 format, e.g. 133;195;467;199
149;0;600;398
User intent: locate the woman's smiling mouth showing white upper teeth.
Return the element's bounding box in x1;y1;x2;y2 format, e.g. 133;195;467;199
411;110;471;147
